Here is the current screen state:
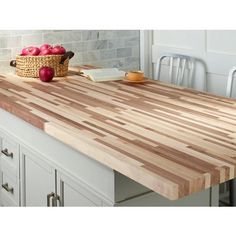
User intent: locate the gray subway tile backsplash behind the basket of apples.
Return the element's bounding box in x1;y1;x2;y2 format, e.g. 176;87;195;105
0;30;139;72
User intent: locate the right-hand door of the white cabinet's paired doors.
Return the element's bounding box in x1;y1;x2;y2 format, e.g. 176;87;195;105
57;172;102;206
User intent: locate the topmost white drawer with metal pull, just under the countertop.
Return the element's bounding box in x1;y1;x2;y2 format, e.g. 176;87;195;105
1;135;19;175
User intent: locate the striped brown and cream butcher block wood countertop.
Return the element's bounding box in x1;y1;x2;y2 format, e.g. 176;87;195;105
0;71;236;200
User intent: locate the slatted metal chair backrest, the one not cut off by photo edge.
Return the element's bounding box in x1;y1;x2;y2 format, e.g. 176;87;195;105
155;53;195;87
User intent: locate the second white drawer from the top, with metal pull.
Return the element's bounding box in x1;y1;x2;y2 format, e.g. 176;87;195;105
1;172;19;205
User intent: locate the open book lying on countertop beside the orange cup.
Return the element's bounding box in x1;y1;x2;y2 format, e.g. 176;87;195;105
80;68;125;82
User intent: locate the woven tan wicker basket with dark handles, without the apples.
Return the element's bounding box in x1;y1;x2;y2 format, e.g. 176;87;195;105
10;52;74;78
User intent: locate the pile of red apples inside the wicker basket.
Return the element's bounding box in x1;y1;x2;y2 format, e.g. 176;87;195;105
20;44;66;56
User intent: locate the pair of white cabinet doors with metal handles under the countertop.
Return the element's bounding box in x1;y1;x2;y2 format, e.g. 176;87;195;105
21;147;103;206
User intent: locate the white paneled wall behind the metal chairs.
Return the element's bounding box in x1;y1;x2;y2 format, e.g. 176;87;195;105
150;30;236;97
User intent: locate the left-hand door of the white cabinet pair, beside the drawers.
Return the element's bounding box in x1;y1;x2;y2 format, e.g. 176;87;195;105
21;148;55;206
